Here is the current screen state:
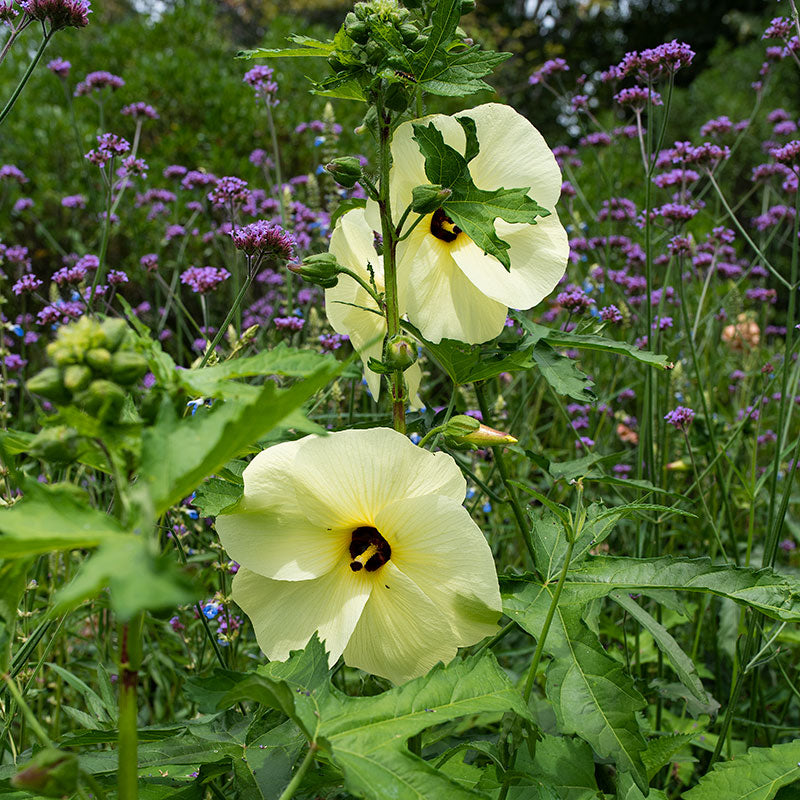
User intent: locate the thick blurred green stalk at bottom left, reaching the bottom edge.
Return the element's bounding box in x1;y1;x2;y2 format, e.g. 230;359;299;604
117;612;144;800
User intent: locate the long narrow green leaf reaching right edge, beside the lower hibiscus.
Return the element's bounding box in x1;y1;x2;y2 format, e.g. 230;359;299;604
565;556;800;622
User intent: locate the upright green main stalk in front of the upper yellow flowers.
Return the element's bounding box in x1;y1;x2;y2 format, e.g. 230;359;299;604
377;99;406;433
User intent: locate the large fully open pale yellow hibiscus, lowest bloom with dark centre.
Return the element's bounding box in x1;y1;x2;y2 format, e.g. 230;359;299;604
212;428;501;683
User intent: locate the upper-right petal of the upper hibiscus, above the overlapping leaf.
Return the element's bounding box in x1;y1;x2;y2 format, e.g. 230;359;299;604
456;103;561;209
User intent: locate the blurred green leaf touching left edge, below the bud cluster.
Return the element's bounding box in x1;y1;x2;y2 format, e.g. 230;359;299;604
0;481;124;558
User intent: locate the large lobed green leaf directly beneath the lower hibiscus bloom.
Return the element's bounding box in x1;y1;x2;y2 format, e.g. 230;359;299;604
221;637;530;800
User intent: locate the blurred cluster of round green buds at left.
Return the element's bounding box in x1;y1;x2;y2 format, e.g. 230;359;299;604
26;317;147;424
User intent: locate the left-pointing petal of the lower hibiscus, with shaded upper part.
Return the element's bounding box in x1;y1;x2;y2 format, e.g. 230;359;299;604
216;442;350;581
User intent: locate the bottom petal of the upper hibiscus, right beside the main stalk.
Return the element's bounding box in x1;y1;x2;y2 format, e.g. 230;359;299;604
398;220;507;344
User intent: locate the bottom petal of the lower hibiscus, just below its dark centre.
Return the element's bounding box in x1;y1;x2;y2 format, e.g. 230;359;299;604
344;561;457;683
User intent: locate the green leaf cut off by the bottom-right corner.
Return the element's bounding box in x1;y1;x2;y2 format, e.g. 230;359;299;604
683;739;800;800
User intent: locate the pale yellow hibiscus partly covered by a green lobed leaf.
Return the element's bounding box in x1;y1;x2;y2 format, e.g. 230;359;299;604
367;103;569;344
